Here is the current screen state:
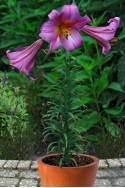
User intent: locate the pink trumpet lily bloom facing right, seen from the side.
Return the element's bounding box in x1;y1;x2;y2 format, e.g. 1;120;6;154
82;17;120;55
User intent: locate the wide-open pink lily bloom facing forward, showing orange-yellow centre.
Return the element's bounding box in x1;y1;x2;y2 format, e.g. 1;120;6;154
39;4;91;53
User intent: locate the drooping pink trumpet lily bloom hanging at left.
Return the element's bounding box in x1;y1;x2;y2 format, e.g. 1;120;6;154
6;39;43;80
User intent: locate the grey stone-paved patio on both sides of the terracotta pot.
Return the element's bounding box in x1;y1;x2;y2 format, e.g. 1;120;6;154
0;158;125;187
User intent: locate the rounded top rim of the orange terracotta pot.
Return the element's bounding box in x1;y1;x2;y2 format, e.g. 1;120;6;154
37;154;99;169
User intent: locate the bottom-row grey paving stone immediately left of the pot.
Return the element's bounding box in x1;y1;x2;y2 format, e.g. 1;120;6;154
19;179;38;187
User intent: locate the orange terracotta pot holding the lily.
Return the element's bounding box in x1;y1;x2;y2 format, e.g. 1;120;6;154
37;154;99;187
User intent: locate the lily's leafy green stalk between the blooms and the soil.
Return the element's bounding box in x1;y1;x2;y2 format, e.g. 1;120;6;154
43;48;80;166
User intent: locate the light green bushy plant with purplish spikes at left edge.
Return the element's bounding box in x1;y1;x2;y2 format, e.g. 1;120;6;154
0;73;33;159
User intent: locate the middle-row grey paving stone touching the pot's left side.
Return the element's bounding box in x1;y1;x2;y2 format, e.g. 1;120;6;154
19;170;39;179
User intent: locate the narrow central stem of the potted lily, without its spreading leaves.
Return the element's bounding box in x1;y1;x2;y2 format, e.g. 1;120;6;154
62;51;75;163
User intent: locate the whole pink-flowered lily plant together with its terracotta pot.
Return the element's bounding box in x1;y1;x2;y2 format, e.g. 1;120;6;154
6;4;120;187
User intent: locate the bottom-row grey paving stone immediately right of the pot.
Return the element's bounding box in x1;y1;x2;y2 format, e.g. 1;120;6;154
95;179;112;187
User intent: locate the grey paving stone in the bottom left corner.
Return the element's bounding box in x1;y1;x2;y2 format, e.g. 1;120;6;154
0;178;19;187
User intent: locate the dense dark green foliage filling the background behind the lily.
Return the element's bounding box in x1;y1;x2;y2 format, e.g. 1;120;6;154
0;0;125;158
